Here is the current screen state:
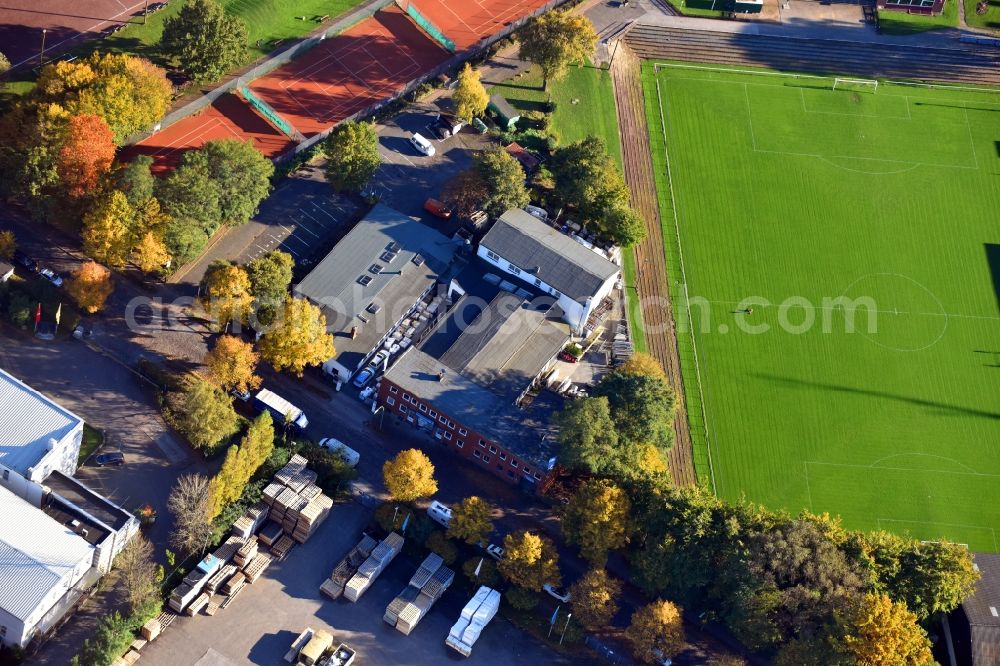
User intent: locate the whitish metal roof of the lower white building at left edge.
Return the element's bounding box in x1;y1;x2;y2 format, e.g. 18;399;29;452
0;486;94;620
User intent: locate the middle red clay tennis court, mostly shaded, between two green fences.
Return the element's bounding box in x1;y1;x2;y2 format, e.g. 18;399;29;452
250;7;449;137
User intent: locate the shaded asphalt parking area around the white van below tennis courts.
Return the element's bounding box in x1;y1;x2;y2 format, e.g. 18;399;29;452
372;104;489;228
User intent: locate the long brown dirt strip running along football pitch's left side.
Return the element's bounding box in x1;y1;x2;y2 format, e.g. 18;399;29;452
611;43;697;486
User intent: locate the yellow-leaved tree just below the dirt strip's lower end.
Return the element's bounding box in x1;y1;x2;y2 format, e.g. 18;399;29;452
561;479;631;566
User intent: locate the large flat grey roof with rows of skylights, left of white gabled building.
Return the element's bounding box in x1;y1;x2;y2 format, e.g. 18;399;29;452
294;204;459;368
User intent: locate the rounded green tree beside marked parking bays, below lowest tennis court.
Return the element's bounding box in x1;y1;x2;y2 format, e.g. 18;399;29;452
195;139;274;226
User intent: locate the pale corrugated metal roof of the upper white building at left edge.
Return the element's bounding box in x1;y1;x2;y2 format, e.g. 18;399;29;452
0;370;83;475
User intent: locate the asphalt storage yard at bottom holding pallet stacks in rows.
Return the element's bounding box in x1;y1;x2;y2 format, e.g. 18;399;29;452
142;502;585;666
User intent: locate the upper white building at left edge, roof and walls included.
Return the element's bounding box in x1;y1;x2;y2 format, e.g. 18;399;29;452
0;370;83;503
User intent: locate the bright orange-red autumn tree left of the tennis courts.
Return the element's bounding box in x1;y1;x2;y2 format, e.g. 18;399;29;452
56;113;115;199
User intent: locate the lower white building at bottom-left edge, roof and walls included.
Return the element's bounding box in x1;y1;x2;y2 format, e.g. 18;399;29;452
0;486;99;646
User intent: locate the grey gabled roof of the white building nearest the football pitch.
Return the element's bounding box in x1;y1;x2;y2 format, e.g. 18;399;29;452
480;208;619;303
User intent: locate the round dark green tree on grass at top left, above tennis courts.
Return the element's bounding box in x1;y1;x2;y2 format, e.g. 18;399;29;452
160;0;249;81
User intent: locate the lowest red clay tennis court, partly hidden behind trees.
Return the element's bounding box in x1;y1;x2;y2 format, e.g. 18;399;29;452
122;94;292;172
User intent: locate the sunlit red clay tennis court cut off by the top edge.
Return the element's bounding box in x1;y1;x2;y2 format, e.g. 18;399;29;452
401;0;546;51
